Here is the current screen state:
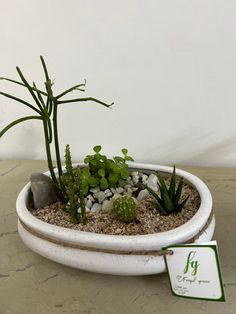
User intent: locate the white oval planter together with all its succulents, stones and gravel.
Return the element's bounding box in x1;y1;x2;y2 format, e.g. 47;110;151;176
0;57;215;275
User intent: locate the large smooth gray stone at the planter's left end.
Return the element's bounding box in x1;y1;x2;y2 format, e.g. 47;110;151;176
30;173;57;208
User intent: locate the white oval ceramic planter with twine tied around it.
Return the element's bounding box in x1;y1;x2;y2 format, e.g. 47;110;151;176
16;163;215;275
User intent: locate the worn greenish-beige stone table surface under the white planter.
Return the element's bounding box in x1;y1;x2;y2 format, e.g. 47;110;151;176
0;160;236;314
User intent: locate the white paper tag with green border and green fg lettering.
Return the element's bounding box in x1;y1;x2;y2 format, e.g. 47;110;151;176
163;241;225;302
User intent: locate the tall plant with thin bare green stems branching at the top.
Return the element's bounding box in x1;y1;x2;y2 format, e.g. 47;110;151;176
0;56;113;200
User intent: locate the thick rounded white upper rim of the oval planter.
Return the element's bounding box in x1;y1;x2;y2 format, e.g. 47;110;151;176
16;162;212;251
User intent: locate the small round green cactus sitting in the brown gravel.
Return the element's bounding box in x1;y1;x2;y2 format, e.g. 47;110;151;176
113;196;137;223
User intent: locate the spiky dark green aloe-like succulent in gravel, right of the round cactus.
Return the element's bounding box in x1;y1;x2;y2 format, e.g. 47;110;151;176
146;166;189;215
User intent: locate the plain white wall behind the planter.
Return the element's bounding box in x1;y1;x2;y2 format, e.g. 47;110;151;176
0;0;236;166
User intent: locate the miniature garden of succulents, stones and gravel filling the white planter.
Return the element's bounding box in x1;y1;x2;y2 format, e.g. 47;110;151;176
0;57;200;235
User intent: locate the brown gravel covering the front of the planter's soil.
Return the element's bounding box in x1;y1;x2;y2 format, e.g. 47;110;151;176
31;184;200;235
